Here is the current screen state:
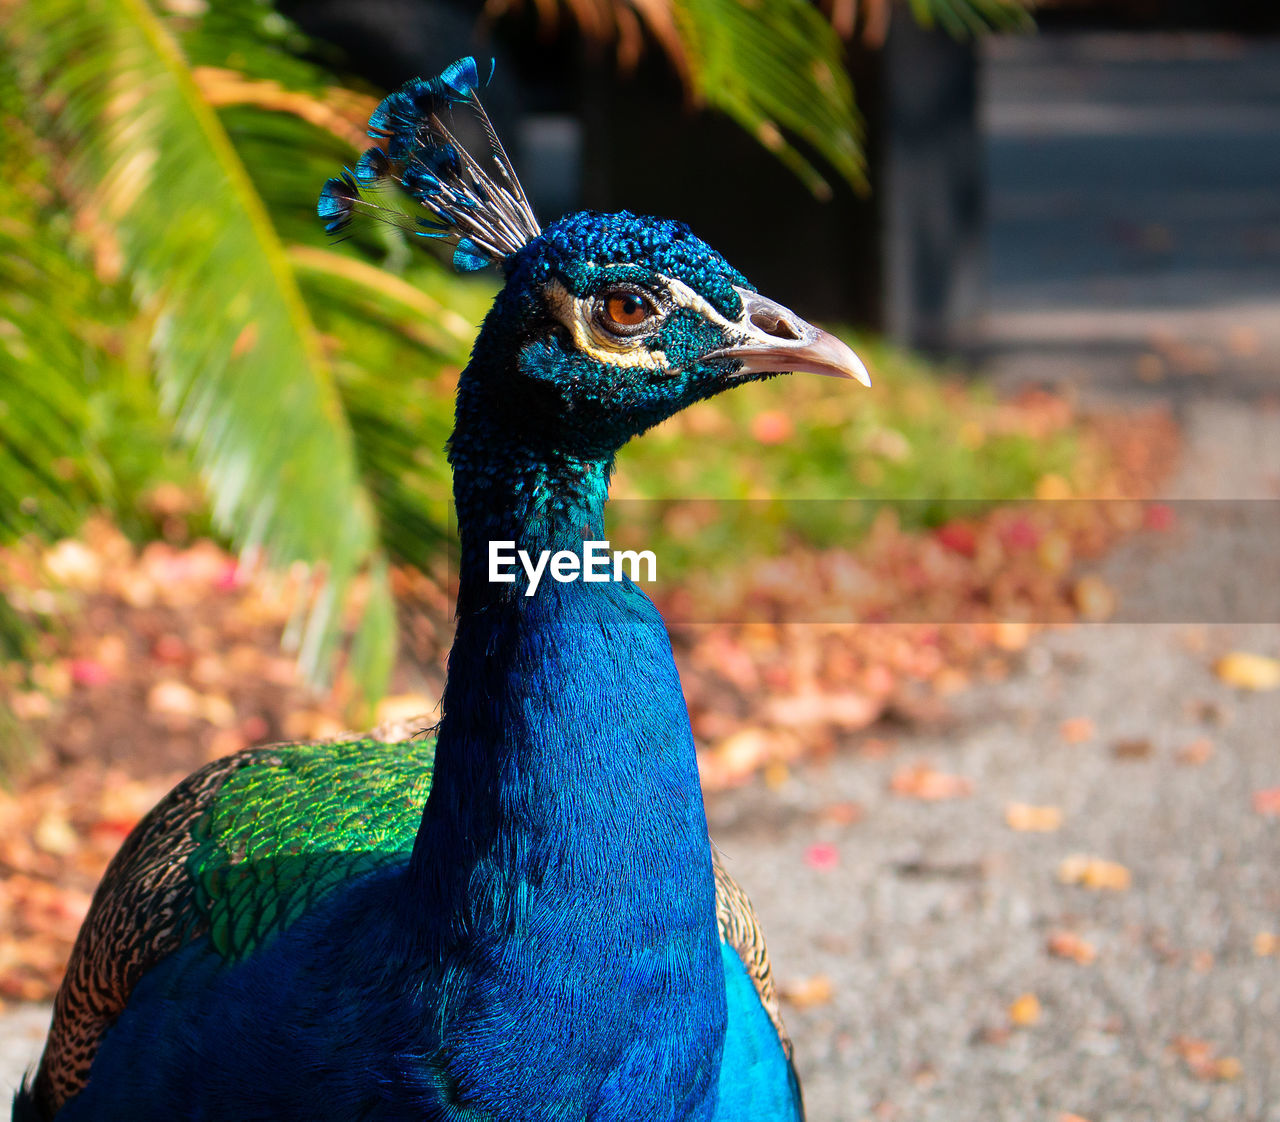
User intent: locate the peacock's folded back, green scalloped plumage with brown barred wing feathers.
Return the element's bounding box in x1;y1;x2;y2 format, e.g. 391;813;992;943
35;738;435;1117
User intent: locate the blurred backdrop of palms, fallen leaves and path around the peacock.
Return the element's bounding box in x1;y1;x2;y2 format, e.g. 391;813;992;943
0;0;1280;1122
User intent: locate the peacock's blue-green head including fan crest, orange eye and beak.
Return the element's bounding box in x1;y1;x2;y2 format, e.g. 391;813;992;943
319;59;870;457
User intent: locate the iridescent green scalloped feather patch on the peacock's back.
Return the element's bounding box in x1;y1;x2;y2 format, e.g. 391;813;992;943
187;739;435;960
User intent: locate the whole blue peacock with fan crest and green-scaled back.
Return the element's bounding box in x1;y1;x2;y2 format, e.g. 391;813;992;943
14;58;870;1122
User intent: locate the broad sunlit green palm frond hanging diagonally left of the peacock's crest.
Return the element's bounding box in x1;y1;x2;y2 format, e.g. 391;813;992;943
17;0;390;674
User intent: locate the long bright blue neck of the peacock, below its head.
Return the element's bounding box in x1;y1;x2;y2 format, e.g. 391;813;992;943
411;391;726;1119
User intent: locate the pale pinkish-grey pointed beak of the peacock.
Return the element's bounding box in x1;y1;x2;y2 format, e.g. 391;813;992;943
707;285;872;388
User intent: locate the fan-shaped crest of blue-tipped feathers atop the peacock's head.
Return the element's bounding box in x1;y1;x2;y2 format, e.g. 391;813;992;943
317;58;541;273
